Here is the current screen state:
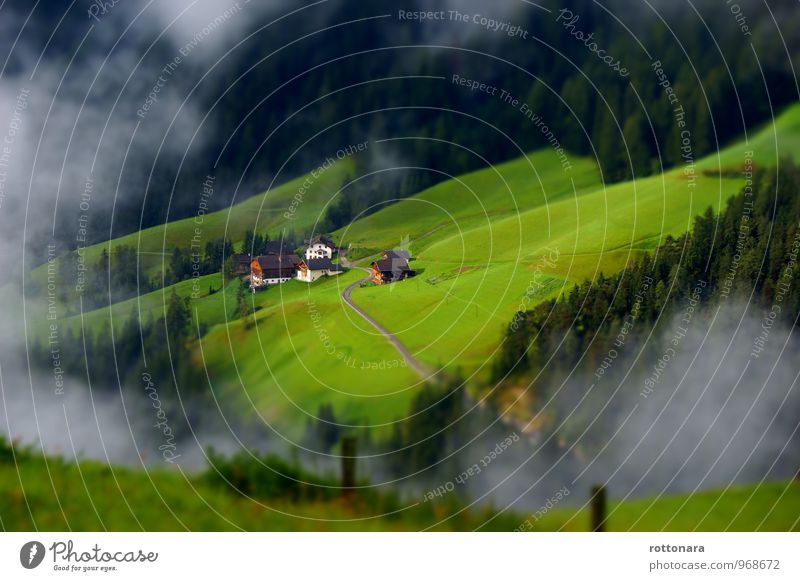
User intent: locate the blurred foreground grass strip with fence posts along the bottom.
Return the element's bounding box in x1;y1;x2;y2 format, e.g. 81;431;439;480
0;444;800;531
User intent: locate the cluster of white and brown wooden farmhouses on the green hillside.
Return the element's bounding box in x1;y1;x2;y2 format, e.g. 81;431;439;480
233;235;415;292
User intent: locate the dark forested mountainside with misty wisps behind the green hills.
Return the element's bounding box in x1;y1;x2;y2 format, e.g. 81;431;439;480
8;0;797;256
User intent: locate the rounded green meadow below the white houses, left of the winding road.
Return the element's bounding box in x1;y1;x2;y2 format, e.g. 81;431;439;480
198;270;420;438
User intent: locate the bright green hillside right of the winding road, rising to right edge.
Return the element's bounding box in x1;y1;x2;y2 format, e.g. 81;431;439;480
340;106;800;371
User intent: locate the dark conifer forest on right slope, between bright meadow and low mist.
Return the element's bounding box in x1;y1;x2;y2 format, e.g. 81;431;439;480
493;159;800;414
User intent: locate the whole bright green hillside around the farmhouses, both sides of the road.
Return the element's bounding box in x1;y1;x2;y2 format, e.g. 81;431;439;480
18;105;800;438
